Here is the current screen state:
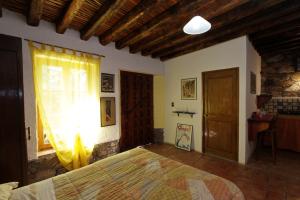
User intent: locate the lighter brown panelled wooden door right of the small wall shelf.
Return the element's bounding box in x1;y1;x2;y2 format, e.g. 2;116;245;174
203;68;239;160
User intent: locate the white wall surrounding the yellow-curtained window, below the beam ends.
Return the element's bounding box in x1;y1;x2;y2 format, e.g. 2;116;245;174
0;9;164;160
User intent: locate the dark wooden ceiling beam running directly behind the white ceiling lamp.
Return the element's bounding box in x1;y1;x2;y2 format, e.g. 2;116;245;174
142;0;282;56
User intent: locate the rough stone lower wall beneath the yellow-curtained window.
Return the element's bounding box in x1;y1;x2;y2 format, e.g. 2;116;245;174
28;141;119;183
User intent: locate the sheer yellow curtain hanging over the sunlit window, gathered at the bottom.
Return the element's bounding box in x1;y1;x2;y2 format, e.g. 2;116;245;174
29;42;100;170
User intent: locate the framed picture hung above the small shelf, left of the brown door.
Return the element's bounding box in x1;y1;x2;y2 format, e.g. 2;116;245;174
181;78;197;100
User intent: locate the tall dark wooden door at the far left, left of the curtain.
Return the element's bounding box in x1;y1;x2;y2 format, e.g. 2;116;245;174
0;35;27;185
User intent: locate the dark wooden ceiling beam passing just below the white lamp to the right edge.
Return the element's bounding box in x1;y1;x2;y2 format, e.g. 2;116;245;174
159;1;300;60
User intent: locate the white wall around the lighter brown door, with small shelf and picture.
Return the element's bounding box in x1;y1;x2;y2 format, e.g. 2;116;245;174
164;36;248;163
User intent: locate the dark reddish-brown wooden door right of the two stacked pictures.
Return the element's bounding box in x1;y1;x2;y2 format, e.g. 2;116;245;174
120;71;153;151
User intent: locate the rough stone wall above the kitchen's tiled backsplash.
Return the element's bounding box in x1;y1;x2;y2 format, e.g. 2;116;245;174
261;53;300;97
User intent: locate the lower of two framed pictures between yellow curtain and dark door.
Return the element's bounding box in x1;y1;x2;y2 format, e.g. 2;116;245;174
100;97;116;127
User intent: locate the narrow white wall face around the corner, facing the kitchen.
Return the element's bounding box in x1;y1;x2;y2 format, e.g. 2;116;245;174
246;38;261;160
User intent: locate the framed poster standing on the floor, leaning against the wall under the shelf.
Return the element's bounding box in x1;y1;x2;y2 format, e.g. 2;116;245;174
175;124;193;151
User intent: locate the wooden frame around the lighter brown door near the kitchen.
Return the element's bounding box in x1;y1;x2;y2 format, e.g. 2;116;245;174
201;67;240;161
